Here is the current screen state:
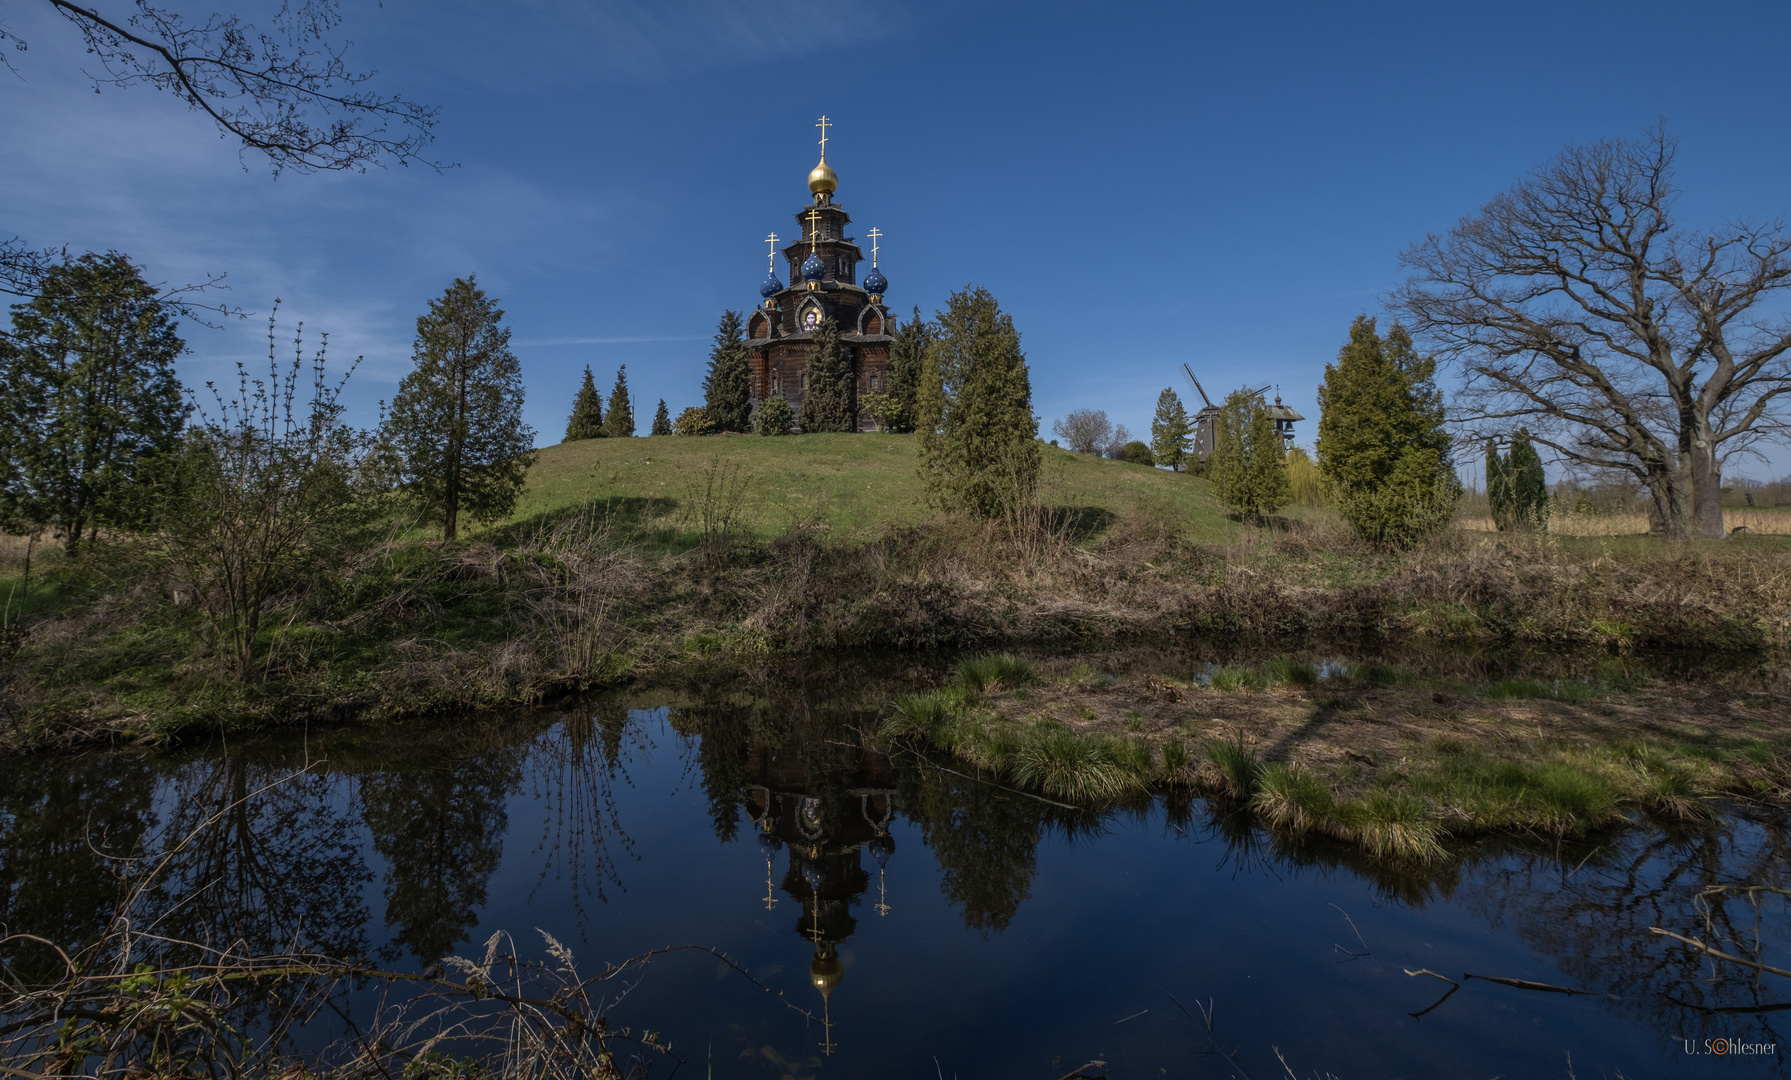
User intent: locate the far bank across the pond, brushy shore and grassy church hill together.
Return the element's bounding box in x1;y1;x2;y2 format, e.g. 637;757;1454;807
0;435;1791;747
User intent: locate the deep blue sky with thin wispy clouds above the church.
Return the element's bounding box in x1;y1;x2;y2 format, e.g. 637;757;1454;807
0;0;1791;476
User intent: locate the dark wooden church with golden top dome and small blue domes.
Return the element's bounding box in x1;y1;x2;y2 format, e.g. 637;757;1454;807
745;116;896;432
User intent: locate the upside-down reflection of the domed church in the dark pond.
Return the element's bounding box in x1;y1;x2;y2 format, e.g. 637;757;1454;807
741;743;897;1055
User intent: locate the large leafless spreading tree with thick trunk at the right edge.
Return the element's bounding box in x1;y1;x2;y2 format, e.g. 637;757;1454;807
1392;127;1791;537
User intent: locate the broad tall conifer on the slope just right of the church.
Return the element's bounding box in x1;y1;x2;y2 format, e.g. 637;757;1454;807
915;288;1041;518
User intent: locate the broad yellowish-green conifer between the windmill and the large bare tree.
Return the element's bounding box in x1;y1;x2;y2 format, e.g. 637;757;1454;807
1318;315;1460;544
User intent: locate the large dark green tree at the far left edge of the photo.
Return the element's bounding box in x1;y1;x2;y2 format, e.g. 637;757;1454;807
0;253;186;552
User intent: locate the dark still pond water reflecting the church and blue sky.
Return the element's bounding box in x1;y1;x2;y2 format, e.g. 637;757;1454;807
0;655;1791;1080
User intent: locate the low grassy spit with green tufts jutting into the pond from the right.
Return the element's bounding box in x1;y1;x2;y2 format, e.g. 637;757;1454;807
878;656;1791;861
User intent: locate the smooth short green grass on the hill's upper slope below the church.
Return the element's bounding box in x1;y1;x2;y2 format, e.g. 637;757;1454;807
512;433;1275;541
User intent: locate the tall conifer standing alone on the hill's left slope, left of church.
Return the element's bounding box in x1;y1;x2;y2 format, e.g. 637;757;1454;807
383;278;536;541
